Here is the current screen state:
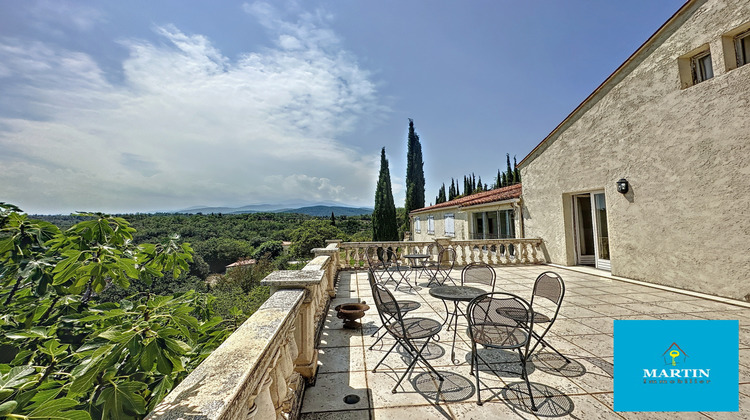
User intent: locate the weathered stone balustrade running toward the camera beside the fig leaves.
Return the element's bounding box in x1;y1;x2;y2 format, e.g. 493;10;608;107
147;241;340;420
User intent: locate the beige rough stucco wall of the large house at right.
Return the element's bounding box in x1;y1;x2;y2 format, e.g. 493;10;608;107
521;0;750;299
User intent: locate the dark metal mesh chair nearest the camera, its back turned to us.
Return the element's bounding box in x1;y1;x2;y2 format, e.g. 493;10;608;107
466;292;537;411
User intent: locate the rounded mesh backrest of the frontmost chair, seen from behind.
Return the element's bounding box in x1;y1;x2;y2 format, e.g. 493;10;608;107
466;292;534;354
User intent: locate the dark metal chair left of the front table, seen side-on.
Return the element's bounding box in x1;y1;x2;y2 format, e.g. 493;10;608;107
372;283;445;394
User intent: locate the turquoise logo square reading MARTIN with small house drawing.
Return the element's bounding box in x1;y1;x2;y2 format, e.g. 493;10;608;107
614;320;739;411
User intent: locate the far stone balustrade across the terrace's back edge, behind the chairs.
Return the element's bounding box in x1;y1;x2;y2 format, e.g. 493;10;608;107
339;238;545;270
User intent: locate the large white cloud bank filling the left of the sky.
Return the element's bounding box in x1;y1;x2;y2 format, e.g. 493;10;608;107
0;7;383;212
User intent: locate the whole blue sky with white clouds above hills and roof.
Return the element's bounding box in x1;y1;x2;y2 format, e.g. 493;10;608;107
0;0;684;214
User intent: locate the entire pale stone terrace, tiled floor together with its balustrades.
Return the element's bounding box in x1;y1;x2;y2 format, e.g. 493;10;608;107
149;239;750;420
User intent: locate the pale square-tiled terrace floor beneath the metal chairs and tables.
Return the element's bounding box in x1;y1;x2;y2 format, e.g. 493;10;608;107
301;266;750;420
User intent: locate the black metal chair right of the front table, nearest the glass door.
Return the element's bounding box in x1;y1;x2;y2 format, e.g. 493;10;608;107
530;271;570;363
